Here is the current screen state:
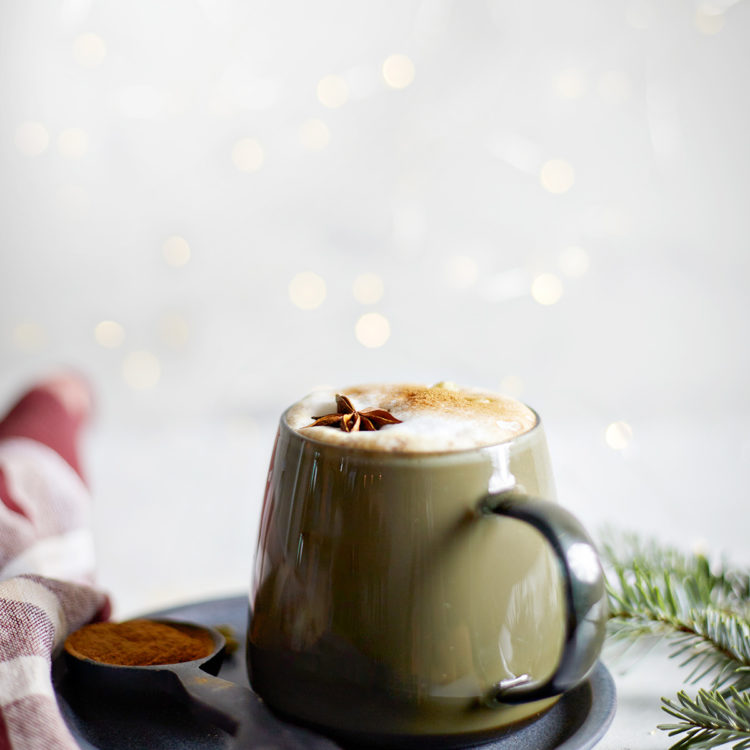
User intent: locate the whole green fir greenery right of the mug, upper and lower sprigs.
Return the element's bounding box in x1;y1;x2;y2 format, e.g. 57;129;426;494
603;536;750;750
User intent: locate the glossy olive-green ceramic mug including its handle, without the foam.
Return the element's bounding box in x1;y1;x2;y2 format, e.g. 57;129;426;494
247;406;606;746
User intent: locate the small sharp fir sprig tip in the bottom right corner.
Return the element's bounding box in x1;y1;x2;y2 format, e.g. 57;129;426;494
658;688;750;750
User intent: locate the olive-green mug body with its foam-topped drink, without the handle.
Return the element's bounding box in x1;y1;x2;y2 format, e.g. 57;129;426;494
253;384;600;746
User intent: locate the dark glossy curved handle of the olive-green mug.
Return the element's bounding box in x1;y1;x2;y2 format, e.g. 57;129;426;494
480;490;607;706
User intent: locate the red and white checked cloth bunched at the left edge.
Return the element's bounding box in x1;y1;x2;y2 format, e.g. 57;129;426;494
0;376;109;750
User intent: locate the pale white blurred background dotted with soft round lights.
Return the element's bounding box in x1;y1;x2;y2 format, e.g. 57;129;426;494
0;0;750;640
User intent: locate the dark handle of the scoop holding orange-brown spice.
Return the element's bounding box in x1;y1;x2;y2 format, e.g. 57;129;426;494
178;670;338;750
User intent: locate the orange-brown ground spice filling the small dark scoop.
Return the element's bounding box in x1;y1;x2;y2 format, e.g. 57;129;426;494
65;620;214;667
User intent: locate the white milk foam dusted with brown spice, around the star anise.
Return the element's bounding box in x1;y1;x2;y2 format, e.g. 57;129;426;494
286;384;537;453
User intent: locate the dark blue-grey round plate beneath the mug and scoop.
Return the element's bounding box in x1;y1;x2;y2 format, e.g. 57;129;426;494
54;596;616;750
